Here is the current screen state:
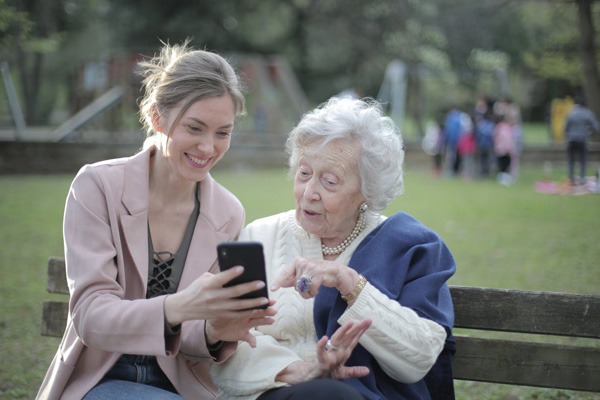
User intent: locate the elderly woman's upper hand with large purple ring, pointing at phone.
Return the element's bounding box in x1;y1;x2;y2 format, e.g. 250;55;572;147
271;257;360;299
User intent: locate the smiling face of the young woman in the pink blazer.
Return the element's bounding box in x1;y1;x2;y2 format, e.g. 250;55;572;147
156;95;235;182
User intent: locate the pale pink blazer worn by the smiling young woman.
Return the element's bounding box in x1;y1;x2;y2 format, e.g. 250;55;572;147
37;148;245;399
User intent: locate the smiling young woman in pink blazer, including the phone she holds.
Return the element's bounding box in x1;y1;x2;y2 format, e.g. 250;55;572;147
38;42;275;400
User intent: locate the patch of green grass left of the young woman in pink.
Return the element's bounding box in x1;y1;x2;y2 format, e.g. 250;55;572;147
0;176;72;399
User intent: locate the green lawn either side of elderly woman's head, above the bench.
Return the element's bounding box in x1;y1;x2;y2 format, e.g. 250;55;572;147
215;163;600;294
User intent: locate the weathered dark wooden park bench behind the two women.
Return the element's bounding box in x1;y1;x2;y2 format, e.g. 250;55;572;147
42;258;600;392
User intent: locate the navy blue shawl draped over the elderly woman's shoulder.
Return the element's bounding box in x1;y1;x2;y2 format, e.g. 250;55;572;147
314;212;456;400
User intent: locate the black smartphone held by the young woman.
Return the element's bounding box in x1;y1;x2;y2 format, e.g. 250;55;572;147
217;242;269;308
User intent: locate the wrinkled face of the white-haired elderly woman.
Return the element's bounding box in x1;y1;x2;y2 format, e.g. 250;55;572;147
294;140;365;246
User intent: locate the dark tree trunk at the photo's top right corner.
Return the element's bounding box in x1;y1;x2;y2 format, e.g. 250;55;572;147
576;0;600;123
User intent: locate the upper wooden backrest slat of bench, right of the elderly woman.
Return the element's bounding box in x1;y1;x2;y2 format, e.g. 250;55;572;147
450;286;600;338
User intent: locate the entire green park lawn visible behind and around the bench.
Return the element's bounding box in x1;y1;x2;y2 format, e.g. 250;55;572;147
0;163;600;400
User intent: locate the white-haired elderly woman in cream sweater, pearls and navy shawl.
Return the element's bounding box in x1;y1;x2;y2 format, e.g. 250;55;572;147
211;99;456;400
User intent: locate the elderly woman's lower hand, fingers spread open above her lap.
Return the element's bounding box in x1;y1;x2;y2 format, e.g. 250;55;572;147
276;319;371;385
